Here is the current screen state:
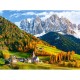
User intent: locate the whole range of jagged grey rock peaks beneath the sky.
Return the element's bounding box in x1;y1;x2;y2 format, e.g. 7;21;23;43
20;15;80;35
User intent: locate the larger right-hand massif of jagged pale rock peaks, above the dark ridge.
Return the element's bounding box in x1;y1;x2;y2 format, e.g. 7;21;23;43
45;15;75;34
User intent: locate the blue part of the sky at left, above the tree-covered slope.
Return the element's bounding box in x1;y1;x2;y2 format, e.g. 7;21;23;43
0;10;65;22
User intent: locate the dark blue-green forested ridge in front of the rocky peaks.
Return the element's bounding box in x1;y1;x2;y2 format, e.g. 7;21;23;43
40;32;80;54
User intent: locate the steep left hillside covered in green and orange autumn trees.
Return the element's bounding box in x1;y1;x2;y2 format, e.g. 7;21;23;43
0;16;45;52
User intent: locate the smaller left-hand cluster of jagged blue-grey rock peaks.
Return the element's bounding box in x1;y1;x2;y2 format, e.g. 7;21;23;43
20;17;43;35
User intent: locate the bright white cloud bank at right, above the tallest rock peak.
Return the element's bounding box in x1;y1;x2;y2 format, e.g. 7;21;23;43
41;11;80;25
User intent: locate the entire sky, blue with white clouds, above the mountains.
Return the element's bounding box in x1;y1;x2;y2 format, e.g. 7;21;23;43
0;10;80;26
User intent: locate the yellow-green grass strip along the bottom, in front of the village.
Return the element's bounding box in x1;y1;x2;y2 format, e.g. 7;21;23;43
0;62;80;70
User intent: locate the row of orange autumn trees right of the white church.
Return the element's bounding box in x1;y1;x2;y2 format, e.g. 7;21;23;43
50;51;75;63
